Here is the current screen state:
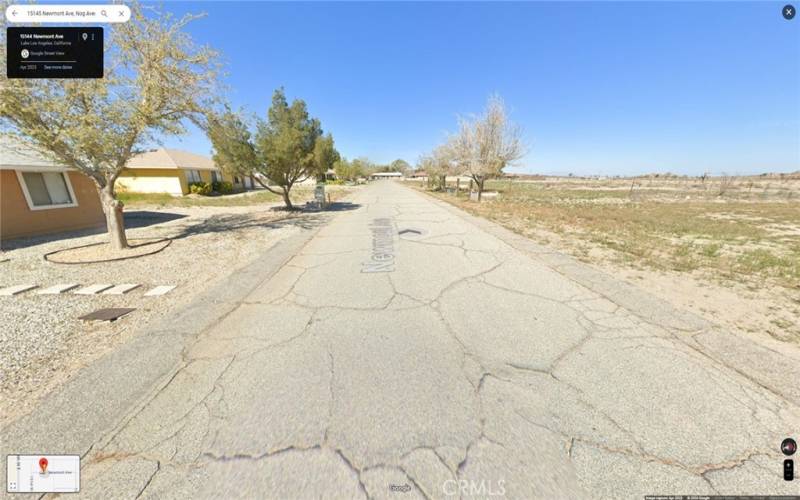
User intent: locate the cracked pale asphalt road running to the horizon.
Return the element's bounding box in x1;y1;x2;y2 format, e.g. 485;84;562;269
7;182;800;499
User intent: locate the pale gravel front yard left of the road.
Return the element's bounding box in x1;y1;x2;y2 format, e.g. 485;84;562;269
0;187;350;427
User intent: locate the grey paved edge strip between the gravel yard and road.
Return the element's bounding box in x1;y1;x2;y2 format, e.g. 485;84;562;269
0;212;336;464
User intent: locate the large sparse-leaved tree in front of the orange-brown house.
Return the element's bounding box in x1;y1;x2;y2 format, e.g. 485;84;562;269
0;3;218;249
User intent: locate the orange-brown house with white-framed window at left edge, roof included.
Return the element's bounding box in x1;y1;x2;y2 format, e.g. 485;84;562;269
0;138;106;241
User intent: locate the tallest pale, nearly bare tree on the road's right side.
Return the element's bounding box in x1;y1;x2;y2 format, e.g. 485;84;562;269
448;95;525;201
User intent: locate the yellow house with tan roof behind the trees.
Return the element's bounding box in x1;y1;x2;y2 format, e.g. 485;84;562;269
117;148;247;196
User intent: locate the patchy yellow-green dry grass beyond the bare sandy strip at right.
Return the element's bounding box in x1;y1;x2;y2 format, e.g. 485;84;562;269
444;179;800;288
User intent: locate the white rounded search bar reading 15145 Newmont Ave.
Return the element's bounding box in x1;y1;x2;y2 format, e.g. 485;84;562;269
6;4;131;24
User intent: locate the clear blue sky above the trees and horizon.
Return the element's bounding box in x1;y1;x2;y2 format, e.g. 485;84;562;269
153;2;800;174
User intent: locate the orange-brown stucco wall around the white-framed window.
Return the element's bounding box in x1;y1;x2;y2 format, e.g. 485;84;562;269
0;170;106;240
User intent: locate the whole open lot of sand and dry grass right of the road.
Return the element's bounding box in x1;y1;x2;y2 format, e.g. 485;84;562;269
418;174;800;343
